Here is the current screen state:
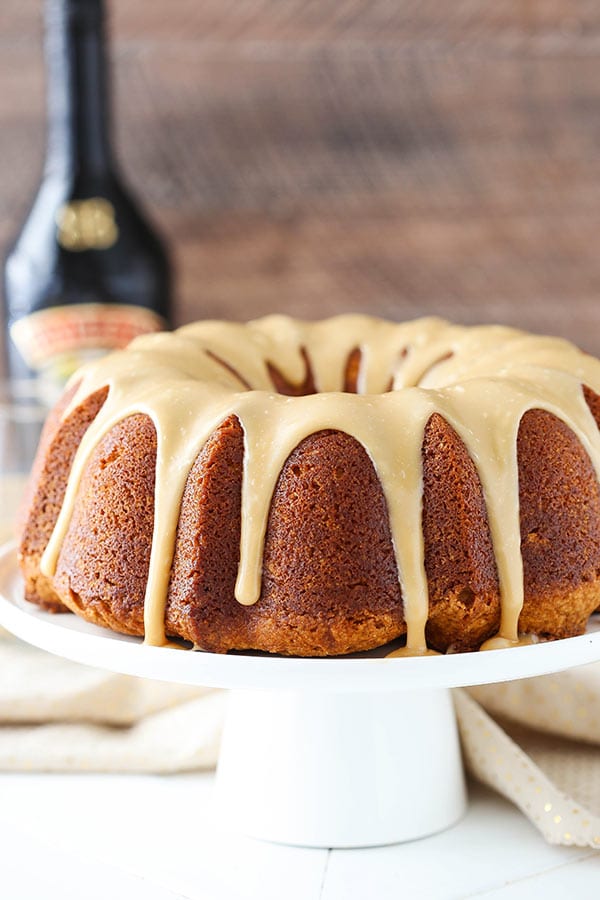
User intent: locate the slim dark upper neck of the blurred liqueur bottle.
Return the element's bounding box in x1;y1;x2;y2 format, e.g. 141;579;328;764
46;0;111;180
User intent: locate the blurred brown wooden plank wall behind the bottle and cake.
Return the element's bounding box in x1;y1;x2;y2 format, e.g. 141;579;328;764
0;0;600;366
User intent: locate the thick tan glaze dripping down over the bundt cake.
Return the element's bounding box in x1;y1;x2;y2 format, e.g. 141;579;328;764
42;316;600;654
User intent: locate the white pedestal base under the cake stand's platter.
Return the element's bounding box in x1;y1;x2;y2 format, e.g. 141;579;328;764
215;689;466;847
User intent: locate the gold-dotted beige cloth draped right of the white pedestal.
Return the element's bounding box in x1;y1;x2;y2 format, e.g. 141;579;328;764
454;663;600;850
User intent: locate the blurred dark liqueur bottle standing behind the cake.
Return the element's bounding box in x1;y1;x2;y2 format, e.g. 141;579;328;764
4;0;170;405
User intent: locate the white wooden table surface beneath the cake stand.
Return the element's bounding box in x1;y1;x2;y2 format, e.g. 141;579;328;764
0;773;600;900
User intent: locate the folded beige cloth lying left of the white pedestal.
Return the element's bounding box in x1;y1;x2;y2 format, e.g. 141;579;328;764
0;632;225;772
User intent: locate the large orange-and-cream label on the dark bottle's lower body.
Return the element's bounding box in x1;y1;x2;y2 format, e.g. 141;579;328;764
10;303;166;405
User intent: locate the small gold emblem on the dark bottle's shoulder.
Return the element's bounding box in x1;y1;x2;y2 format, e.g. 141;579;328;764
56;197;119;251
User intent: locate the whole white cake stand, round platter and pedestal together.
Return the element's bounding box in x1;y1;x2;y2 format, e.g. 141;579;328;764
0;545;600;847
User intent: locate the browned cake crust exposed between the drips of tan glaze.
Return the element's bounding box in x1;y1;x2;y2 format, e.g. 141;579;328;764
15;359;600;656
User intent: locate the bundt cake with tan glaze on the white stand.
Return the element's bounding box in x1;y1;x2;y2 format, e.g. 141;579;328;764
15;316;600;656
